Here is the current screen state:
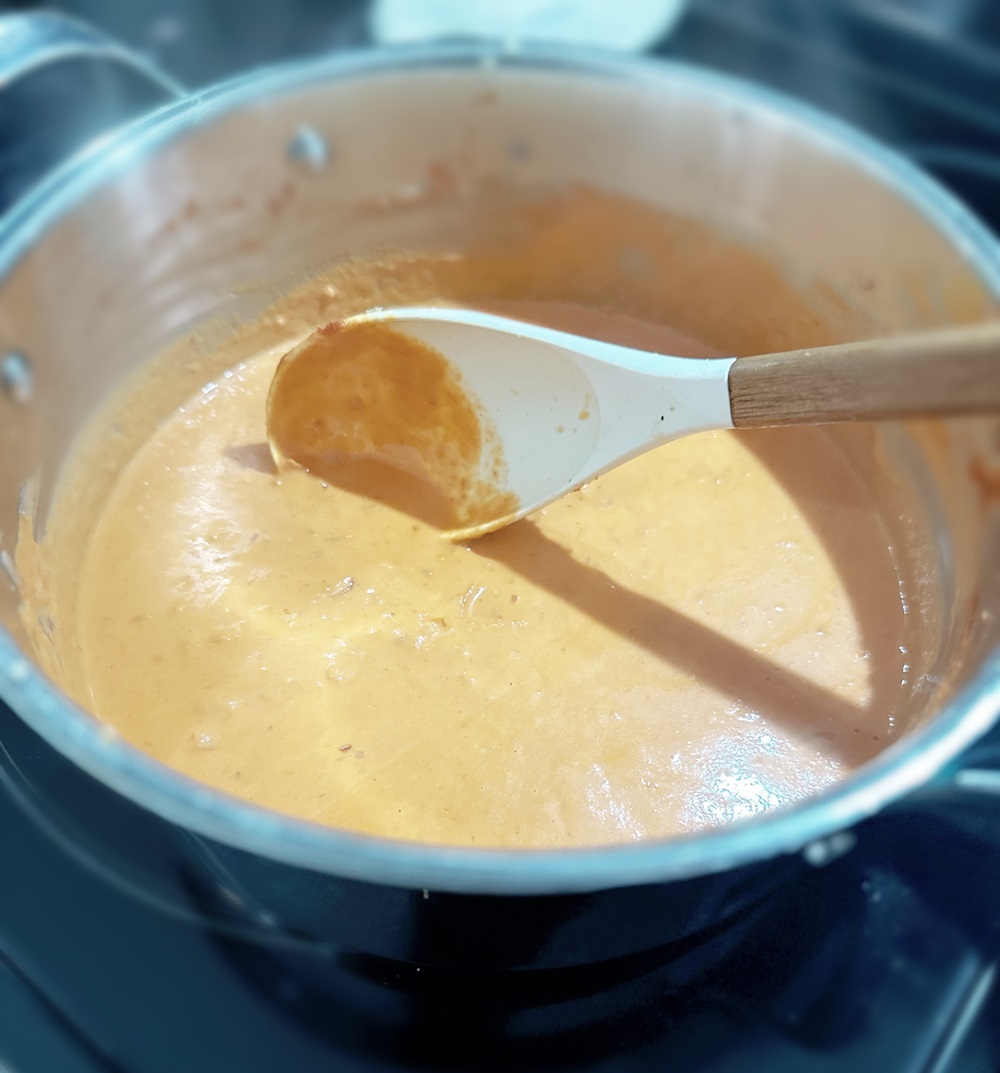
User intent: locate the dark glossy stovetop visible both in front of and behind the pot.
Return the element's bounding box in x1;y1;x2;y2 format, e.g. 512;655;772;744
0;0;1000;1073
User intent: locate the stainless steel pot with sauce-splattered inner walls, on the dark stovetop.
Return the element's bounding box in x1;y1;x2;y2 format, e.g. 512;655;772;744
0;12;1000;969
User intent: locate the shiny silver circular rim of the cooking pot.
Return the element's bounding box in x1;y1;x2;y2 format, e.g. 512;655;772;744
0;43;1000;895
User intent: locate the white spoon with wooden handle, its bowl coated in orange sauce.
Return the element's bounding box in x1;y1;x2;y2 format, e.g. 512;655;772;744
267;308;1000;540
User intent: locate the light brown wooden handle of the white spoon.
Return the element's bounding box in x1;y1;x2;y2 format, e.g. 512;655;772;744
730;322;1000;428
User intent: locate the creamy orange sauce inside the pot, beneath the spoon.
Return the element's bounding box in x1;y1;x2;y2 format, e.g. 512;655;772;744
25;188;931;847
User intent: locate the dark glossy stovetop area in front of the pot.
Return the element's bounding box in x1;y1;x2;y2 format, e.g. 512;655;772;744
0;763;1000;1073
